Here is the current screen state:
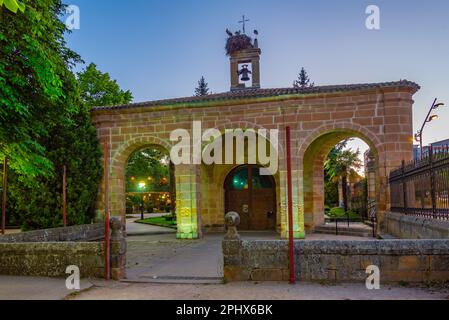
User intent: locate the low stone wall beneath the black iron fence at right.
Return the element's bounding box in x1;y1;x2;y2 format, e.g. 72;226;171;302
382;212;449;239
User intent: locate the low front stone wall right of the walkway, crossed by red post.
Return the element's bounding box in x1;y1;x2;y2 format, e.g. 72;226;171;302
223;240;449;283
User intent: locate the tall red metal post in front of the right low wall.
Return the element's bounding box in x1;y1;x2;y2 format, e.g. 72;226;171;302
286;127;295;284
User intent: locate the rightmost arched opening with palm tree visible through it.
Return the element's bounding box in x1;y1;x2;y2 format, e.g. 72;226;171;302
303;129;380;233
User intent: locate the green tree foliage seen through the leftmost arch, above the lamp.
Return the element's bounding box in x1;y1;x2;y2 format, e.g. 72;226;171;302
126;148;170;192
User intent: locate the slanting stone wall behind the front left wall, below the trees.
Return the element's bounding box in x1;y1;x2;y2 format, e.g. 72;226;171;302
0;223;104;243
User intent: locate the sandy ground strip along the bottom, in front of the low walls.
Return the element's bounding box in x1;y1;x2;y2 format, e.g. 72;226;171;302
73;282;449;300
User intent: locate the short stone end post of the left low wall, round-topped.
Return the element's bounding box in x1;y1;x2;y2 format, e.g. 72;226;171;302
110;217;126;280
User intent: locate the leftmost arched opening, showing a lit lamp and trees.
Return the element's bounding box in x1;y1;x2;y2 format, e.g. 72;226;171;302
125;146;176;226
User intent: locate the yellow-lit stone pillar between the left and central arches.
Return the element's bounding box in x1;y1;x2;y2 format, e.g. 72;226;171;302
176;165;201;239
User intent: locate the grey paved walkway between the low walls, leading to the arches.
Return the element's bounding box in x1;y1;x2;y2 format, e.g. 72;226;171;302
125;219;369;284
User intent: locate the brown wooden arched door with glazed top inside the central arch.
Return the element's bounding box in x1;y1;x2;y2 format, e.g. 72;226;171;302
224;165;276;231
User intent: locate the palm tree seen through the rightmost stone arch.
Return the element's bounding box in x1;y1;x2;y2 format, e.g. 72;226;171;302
324;140;362;211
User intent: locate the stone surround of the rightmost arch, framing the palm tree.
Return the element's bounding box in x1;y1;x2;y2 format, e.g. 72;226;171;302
300;123;387;232
